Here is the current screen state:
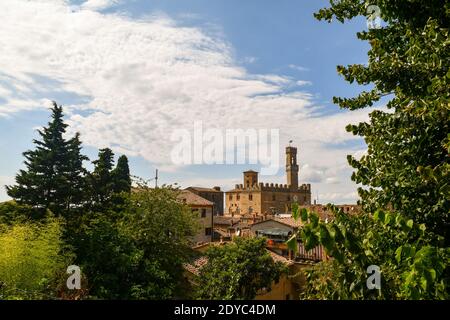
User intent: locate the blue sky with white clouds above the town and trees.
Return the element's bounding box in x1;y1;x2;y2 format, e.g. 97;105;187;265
0;0;380;204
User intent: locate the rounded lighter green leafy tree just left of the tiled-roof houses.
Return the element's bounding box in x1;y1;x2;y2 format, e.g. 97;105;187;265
121;186;199;299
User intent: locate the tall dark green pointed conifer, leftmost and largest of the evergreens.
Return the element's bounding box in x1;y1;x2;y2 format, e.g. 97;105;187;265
7;102;87;215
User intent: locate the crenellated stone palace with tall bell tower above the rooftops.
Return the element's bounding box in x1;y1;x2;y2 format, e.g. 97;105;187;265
225;146;311;216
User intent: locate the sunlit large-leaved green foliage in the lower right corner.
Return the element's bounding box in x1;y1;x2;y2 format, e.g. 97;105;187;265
288;206;450;299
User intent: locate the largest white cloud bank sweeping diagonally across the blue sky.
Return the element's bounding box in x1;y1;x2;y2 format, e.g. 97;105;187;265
0;0;367;204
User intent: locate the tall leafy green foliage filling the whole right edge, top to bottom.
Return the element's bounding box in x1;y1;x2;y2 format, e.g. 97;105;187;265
297;0;450;299
